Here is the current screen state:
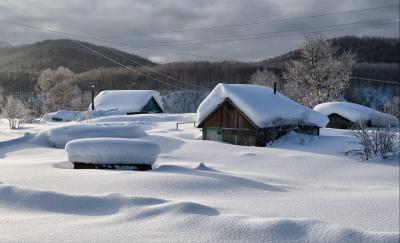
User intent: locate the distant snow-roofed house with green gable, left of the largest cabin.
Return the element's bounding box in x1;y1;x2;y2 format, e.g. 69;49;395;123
94;90;164;115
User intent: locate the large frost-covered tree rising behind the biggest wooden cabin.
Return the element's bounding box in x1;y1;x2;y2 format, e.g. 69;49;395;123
283;34;356;107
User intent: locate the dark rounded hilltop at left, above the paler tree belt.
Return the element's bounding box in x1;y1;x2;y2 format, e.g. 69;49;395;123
0;39;151;73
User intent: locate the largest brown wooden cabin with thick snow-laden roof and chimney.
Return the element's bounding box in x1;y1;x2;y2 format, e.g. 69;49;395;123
197;84;328;146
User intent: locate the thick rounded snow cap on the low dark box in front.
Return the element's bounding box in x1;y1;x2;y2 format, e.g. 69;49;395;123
65;138;161;165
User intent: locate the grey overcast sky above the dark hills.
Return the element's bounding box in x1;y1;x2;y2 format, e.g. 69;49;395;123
0;0;399;62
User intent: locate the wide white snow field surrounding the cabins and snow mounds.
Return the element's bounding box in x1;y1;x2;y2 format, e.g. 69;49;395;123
0;114;399;242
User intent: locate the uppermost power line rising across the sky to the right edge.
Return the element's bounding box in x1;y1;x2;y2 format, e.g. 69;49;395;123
97;4;399;38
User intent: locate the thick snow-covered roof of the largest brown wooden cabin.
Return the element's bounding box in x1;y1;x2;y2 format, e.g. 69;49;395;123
197;83;329;128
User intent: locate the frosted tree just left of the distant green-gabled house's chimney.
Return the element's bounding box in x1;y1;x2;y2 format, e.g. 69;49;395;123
38;67;80;111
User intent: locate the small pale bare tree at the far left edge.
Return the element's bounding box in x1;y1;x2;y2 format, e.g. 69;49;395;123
1;96;29;129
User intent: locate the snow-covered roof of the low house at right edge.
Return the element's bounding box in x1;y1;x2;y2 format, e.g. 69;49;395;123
314;102;399;126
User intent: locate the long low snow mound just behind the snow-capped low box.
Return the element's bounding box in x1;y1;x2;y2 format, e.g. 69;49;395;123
34;123;147;148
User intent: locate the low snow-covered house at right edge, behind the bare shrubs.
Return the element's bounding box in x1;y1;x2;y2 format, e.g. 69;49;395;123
314;102;399;129
